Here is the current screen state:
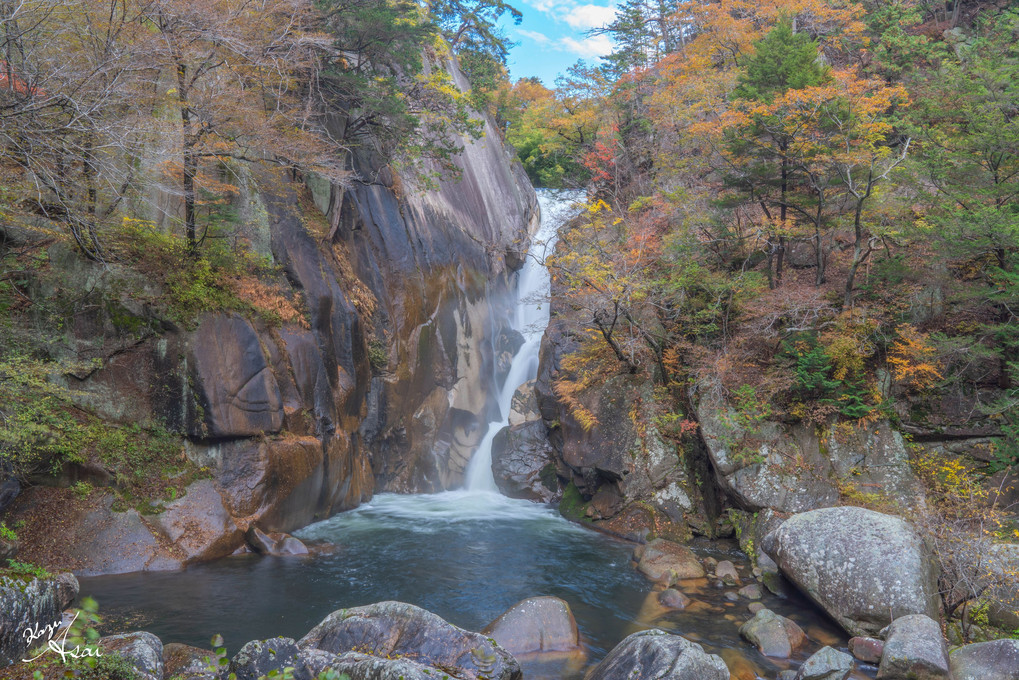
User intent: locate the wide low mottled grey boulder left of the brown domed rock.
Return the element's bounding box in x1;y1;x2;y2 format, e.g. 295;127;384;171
301;601;521;680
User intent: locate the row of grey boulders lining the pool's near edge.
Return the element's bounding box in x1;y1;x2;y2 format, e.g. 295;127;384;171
0;570;1019;680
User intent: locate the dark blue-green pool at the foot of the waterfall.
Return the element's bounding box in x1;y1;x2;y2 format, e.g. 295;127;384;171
82;491;860;680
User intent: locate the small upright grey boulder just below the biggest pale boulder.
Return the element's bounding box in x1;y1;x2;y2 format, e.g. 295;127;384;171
877;614;952;680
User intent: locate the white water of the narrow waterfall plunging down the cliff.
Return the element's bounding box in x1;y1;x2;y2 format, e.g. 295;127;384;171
464;191;582;492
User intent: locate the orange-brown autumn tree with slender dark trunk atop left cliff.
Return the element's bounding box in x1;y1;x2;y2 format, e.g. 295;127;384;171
137;0;343;253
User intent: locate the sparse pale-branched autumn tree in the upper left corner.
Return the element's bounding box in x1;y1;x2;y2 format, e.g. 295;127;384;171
0;0;148;260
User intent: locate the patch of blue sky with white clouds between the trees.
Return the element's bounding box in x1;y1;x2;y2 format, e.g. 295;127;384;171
505;0;614;87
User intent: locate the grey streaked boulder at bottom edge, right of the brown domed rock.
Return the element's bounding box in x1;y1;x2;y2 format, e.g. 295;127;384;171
585;629;729;680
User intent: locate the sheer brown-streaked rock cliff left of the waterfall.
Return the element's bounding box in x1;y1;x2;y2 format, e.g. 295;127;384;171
0;55;539;574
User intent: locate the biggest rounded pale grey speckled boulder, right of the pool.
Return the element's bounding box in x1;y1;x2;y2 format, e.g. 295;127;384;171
763;507;937;635
